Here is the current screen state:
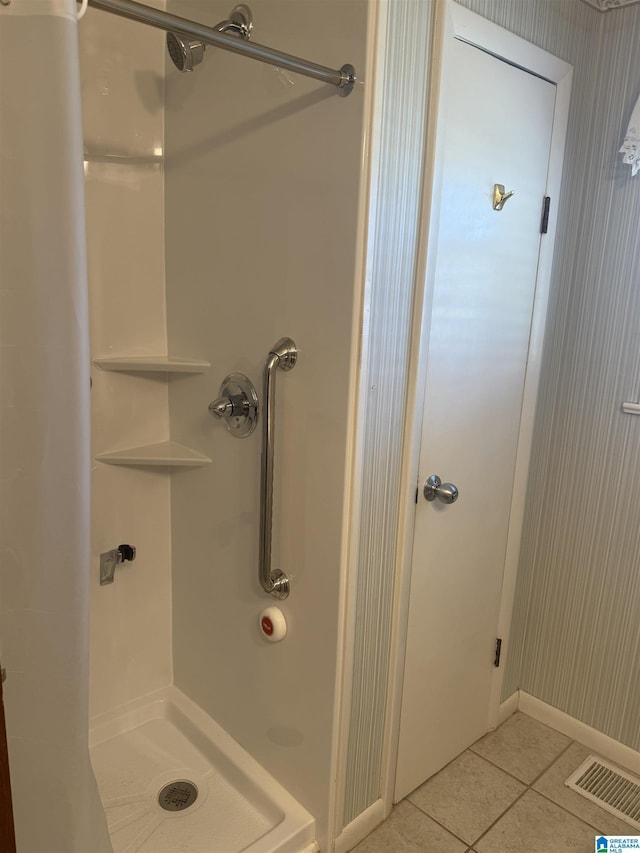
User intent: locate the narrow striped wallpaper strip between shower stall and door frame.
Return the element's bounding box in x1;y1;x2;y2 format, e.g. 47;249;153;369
343;0;431;825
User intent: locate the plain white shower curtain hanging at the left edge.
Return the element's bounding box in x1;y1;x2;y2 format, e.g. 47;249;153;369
0;0;111;853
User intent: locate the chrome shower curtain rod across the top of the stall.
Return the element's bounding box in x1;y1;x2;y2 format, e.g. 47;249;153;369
89;0;356;97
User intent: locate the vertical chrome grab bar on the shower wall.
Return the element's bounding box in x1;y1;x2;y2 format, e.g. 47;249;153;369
259;338;298;599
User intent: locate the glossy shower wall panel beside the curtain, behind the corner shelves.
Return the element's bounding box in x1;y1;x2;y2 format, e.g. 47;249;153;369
80;4;171;714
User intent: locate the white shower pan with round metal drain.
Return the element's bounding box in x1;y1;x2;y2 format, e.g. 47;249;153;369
90;686;318;853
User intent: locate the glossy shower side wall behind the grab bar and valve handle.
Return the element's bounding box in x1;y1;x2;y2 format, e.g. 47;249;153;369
166;0;366;844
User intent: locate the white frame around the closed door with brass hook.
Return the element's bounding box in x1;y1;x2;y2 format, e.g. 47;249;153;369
384;0;573;802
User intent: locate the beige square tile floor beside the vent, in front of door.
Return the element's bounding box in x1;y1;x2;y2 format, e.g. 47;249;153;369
353;712;640;853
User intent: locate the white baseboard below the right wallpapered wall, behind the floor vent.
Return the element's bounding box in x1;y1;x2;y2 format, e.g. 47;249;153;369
520;690;640;774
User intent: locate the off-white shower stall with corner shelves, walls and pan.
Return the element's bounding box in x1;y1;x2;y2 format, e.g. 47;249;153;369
80;0;367;853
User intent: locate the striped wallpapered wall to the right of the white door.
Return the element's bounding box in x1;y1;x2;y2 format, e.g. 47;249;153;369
456;0;640;749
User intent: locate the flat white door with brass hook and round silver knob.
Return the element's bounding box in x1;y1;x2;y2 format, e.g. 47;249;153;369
395;30;556;801
